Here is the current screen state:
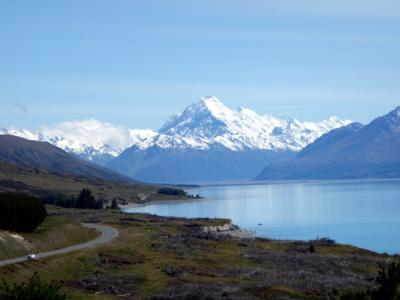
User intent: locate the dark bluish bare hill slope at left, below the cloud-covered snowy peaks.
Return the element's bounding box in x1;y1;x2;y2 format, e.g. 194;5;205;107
0;135;132;182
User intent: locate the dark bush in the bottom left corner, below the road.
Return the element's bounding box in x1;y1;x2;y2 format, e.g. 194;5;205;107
0;273;67;300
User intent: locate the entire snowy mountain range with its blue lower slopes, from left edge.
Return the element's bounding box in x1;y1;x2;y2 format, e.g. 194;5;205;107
0;97;350;183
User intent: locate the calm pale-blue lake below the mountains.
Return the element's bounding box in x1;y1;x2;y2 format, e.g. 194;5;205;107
128;180;400;254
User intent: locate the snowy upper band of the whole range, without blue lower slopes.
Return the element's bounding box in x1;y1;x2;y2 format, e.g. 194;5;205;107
0;97;351;164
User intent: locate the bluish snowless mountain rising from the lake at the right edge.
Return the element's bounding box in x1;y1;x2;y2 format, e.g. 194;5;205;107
256;107;400;180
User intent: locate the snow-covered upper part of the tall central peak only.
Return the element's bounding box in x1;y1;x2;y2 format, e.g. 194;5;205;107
153;97;351;151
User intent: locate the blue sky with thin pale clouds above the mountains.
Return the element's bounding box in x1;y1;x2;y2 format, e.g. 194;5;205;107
0;0;400;129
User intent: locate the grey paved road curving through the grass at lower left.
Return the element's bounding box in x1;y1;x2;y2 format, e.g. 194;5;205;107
0;223;118;267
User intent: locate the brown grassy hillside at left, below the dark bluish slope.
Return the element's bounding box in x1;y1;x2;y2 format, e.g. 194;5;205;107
0;161;191;203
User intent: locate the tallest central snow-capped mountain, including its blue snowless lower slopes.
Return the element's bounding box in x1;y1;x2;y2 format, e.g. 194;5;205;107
107;97;351;183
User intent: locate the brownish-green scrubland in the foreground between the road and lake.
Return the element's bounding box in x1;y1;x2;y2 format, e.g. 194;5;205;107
0;208;395;300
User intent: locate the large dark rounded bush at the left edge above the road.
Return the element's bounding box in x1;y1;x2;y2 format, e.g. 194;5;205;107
0;193;46;232
